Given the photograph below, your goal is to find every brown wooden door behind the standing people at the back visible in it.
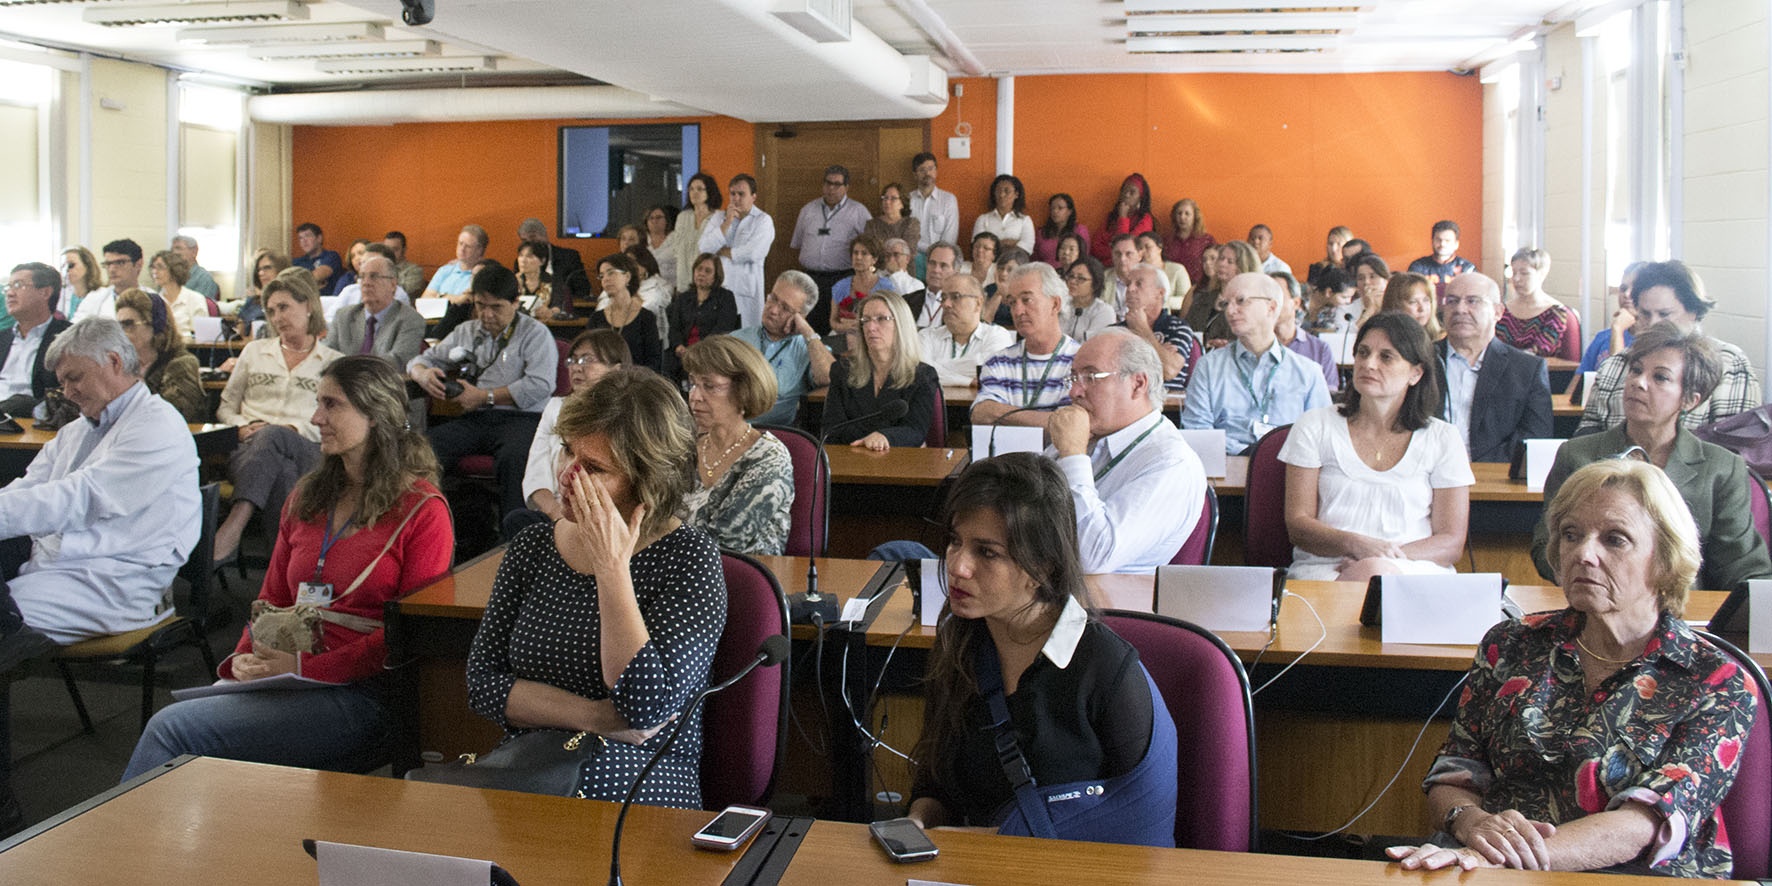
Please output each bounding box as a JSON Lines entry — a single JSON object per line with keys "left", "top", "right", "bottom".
{"left": 757, "top": 120, "right": 929, "bottom": 289}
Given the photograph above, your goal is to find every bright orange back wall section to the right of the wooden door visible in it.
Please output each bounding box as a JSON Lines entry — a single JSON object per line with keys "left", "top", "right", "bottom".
{"left": 930, "top": 73, "right": 1483, "bottom": 275}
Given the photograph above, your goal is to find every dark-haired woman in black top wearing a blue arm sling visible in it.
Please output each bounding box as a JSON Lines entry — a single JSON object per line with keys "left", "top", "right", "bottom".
{"left": 909, "top": 452, "right": 1177, "bottom": 845}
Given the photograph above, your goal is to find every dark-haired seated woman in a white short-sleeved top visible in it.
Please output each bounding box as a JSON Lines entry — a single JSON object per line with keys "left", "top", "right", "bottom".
{"left": 1279, "top": 312, "right": 1476, "bottom": 581}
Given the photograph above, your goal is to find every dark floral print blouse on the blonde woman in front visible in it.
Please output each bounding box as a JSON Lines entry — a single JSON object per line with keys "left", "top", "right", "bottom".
{"left": 1423, "top": 610, "right": 1754, "bottom": 877}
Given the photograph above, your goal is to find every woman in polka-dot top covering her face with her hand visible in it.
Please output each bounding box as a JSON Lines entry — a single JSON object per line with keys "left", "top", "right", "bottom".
{"left": 468, "top": 366, "right": 727, "bottom": 810}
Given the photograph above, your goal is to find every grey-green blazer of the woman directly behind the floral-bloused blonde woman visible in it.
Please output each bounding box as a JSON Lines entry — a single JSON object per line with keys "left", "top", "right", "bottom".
{"left": 1533, "top": 425, "right": 1772, "bottom": 590}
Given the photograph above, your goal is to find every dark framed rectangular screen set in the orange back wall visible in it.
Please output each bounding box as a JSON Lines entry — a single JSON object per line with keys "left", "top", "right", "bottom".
{"left": 556, "top": 122, "right": 702, "bottom": 237}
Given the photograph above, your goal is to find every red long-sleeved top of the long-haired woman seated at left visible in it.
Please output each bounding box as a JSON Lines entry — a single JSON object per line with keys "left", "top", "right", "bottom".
{"left": 220, "top": 480, "right": 455, "bottom": 684}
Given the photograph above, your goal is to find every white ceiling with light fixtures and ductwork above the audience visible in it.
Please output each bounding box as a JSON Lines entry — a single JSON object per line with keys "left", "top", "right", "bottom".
{"left": 0, "top": 0, "right": 1604, "bottom": 120}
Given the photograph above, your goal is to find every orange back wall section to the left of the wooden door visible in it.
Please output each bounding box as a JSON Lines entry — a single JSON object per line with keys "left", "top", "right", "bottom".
{"left": 282, "top": 117, "right": 757, "bottom": 269}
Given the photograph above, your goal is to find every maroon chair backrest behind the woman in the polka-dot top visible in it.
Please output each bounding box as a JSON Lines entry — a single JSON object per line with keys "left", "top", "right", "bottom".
{"left": 702, "top": 553, "right": 792, "bottom": 810}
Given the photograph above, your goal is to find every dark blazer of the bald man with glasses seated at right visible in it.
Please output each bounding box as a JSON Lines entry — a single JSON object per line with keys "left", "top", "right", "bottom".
{"left": 1434, "top": 338, "right": 1551, "bottom": 461}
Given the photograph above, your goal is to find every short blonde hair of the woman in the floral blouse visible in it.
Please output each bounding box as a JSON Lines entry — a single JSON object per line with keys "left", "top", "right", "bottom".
{"left": 1545, "top": 459, "right": 1701, "bottom": 617}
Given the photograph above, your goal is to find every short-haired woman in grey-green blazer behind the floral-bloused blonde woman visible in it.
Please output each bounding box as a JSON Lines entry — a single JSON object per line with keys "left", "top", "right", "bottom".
{"left": 1533, "top": 323, "right": 1772, "bottom": 590}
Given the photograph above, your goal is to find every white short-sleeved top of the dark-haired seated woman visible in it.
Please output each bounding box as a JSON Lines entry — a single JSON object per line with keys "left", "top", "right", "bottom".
{"left": 1279, "top": 406, "right": 1476, "bottom": 581}
